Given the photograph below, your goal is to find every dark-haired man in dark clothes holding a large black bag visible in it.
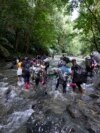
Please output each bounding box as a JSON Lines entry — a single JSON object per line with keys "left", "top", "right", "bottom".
{"left": 71, "top": 59, "right": 87, "bottom": 93}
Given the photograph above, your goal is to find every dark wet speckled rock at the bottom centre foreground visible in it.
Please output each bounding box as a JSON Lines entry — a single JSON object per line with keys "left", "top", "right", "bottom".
{"left": 27, "top": 112, "right": 88, "bottom": 133}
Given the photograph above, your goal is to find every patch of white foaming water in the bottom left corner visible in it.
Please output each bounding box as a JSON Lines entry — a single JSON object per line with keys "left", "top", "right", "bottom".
{"left": 1, "top": 109, "right": 33, "bottom": 133}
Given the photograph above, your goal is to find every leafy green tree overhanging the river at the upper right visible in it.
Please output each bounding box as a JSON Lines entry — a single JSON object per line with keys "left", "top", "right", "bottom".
{"left": 69, "top": 0, "right": 100, "bottom": 52}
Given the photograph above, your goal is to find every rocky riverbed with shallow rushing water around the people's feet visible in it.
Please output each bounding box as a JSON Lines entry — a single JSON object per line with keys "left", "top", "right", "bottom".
{"left": 0, "top": 57, "right": 100, "bottom": 133}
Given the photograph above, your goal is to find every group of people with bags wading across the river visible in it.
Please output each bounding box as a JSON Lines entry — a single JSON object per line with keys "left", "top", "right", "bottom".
{"left": 16, "top": 55, "right": 98, "bottom": 94}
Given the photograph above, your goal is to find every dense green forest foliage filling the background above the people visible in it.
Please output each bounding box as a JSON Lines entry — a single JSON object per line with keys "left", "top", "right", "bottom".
{"left": 0, "top": 0, "right": 100, "bottom": 57}
